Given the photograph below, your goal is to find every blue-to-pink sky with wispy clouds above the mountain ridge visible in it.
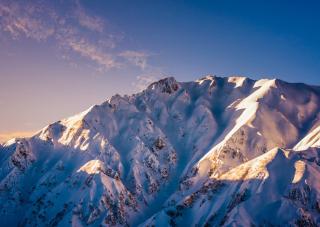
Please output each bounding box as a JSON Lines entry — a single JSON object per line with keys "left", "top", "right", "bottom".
{"left": 0, "top": 0, "right": 320, "bottom": 141}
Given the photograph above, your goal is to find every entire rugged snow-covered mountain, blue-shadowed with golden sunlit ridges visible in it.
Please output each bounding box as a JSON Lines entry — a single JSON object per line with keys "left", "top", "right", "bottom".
{"left": 0, "top": 76, "right": 320, "bottom": 226}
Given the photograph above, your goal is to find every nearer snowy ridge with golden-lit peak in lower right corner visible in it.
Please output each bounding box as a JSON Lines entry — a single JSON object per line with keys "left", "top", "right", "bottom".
{"left": 144, "top": 148, "right": 320, "bottom": 226}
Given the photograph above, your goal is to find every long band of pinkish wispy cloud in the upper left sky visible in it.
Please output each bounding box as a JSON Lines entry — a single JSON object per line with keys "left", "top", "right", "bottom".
{"left": 0, "top": 0, "right": 149, "bottom": 71}
